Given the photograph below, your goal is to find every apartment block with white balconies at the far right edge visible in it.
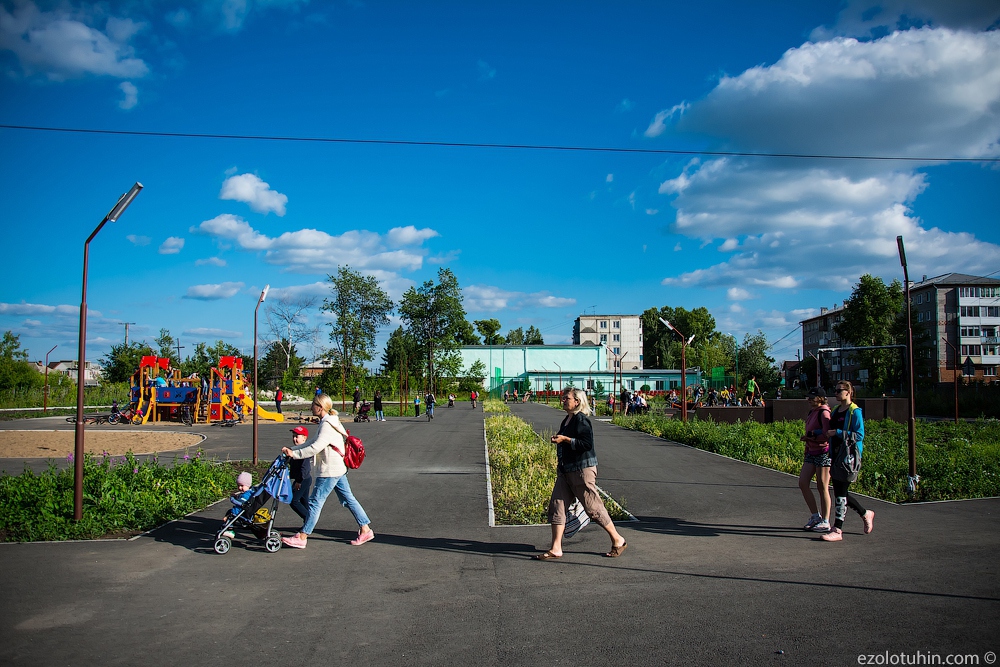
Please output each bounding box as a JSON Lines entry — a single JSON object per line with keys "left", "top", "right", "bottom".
{"left": 910, "top": 273, "right": 1000, "bottom": 382}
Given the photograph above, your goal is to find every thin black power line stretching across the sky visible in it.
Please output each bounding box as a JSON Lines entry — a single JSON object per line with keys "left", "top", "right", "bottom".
{"left": 0, "top": 124, "right": 1000, "bottom": 164}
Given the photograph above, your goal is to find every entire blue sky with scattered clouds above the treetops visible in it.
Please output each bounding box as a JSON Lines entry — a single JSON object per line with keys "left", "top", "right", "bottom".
{"left": 0, "top": 0, "right": 1000, "bottom": 370}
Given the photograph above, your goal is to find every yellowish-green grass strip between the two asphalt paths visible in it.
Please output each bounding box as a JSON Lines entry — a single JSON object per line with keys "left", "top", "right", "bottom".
{"left": 483, "top": 410, "right": 630, "bottom": 525}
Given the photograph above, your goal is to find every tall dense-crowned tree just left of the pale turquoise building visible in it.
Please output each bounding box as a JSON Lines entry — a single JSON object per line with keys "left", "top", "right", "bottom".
{"left": 399, "top": 268, "right": 468, "bottom": 391}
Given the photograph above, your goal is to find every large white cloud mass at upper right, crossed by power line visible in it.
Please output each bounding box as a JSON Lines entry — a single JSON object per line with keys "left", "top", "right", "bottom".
{"left": 659, "top": 29, "right": 1000, "bottom": 292}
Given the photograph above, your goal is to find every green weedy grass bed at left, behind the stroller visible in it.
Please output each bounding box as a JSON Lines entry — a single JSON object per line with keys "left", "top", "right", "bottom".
{"left": 0, "top": 451, "right": 270, "bottom": 542}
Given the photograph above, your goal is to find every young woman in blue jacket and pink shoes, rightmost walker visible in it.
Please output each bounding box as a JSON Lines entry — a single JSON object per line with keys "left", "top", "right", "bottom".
{"left": 823, "top": 380, "right": 875, "bottom": 542}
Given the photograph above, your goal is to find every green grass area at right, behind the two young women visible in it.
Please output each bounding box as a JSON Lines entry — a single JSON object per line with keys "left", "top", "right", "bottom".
{"left": 614, "top": 416, "right": 1000, "bottom": 502}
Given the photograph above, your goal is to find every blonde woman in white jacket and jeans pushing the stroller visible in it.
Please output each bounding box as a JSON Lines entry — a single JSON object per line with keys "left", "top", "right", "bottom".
{"left": 281, "top": 394, "right": 375, "bottom": 549}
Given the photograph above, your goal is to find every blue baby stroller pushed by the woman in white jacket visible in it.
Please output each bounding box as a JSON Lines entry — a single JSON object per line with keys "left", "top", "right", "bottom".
{"left": 215, "top": 454, "right": 292, "bottom": 554}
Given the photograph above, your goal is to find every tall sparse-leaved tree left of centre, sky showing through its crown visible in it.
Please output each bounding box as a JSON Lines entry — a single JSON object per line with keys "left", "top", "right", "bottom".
{"left": 322, "top": 266, "right": 394, "bottom": 373}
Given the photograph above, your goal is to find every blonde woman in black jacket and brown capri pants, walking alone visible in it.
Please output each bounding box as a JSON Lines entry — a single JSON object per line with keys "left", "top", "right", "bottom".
{"left": 534, "top": 388, "right": 628, "bottom": 560}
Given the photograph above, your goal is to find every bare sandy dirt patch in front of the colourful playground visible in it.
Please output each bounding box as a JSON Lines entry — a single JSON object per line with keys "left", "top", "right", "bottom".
{"left": 0, "top": 431, "right": 203, "bottom": 459}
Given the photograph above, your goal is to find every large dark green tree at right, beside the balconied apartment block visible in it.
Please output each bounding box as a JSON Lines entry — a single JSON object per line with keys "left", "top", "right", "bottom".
{"left": 834, "top": 273, "right": 905, "bottom": 389}
